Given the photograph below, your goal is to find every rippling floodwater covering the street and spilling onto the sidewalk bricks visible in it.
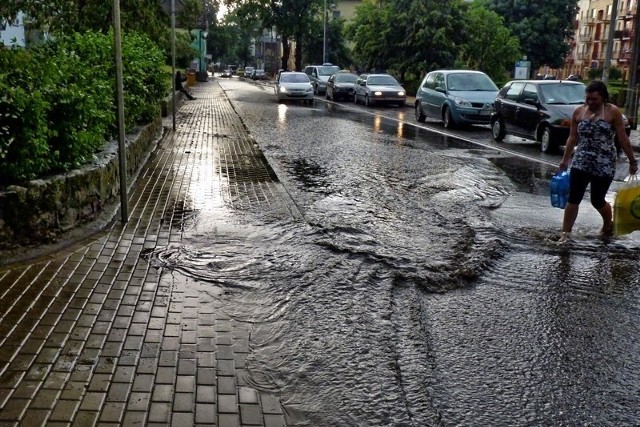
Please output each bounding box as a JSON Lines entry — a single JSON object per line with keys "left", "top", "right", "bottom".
{"left": 151, "top": 82, "right": 640, "bottom": 427}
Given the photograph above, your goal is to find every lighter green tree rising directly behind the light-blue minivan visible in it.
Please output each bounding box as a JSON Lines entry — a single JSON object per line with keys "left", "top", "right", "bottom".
{"left": 457, "top": 2, "right": 521, "bottom": 81}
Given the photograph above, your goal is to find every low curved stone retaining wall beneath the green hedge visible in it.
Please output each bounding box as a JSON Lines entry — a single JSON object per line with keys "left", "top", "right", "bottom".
{"left": 0, "top": 117, "right": 165, "bottom": 250}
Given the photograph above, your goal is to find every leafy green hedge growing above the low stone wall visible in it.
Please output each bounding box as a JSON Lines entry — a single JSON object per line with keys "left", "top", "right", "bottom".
{"left": 0, "top": 32, "right": 170, "bottom": 182}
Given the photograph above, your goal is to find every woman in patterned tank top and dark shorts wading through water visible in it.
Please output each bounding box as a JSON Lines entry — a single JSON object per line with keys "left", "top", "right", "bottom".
{"left": 560, "top": 80, "right": 638, "bottom": 242}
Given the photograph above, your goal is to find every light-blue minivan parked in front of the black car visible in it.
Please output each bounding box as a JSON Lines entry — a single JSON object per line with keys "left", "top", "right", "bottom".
{"left": 414, "top": 70, "right": 498, "bottom": 129}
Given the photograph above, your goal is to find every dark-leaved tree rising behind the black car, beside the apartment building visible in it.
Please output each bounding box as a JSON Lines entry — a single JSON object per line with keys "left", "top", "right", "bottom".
{"left": 477, "top": 0, "right": 578, "bottom": 70}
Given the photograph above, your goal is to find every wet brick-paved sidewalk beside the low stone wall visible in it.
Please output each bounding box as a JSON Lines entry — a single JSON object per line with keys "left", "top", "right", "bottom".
{"left": 0, "top": 81, "right": 287, "bottom": 427}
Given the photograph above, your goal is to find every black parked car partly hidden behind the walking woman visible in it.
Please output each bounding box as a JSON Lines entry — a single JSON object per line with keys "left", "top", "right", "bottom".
{"left": 491, "top": 80, "right": 631, "bottom": 153}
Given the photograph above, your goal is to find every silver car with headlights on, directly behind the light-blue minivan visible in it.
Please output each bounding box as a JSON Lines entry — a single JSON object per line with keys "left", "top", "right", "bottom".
{"left": 353, "top": 74, "right": 407, "bottom": 107}
